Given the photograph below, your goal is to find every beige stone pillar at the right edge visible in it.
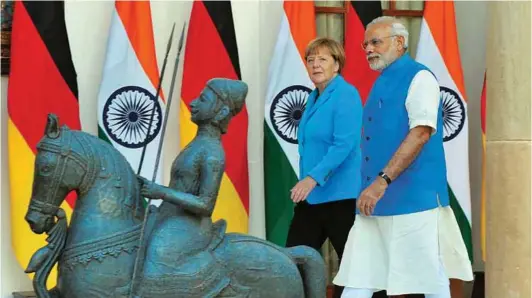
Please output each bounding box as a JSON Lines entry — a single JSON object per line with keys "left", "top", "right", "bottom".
{"left": 486, "top": 1, "right": 532, "bottom": 298}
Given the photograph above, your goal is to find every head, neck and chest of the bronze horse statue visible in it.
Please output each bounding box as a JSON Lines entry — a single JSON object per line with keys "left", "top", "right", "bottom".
{"left": 25, "top": 114, "right": 150, "bottom": 297}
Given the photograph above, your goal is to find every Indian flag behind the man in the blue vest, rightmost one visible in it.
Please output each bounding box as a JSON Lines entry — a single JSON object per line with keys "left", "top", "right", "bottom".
{"left": 416, "top": 1, "right": 473, "bottom": 260}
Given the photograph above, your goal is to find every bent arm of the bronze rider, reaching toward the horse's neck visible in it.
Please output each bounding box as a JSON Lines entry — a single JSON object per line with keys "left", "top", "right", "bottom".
{"left": 138, "top": 157, "right": 224, "bottom": 216}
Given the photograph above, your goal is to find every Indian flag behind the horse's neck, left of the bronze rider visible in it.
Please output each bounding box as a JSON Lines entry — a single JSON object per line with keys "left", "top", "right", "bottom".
{"left": 98, "top": 1, "right": 165, "bottom": 191}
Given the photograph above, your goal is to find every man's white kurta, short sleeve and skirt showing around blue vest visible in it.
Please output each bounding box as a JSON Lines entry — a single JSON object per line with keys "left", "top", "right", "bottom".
{"left": 333, "top": 70, "right": 473, "bottom": 295}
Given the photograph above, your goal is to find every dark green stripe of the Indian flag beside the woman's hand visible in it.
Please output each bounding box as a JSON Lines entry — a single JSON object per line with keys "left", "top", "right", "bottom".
{"left": 264, "top": 122, "right": 297, "bottom": 246}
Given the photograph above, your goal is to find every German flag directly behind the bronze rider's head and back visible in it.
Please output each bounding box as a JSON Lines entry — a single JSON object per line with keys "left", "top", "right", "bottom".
{"left": 179, "top": 1, "right": 249, "bottom": 233}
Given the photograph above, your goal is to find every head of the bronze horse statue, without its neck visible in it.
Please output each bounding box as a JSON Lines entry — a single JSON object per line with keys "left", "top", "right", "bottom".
{"left": 25, "top": 114, "right": 94, "bottom": 234}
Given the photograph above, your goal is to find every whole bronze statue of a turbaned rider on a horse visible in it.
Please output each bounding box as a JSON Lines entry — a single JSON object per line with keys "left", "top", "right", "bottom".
{"left": 22, "top": 79, "right": 326, "bottom": 298}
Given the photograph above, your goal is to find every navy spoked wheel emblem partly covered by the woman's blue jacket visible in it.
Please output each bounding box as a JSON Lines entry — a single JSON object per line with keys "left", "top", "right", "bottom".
{"left": 270, "top": 85, "right": 312, "bottom": 144}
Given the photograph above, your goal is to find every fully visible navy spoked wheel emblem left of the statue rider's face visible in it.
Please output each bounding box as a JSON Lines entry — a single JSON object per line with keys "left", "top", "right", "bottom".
{"left": 102, "top": 86, "right": 162, "bottom": 148}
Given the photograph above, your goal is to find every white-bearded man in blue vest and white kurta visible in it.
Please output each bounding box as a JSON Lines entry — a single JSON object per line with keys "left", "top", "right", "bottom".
{"left": 334, "top": 17, "right": 473, "bottom": 298}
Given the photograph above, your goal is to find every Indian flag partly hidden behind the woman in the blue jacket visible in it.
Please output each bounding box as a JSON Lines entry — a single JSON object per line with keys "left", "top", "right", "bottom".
{"left": 264, "top": 1, "right": 316, "bottom": 246}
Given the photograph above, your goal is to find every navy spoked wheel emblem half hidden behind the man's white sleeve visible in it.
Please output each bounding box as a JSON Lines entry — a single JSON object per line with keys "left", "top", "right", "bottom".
{"left": 440, "top": 87, "right": 466, "bottom": 142}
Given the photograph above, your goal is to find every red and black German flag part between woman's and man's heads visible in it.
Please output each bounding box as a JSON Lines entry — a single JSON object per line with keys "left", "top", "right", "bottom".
{"left": 342, "top": 1, "right": 382, "bottom": 103}
